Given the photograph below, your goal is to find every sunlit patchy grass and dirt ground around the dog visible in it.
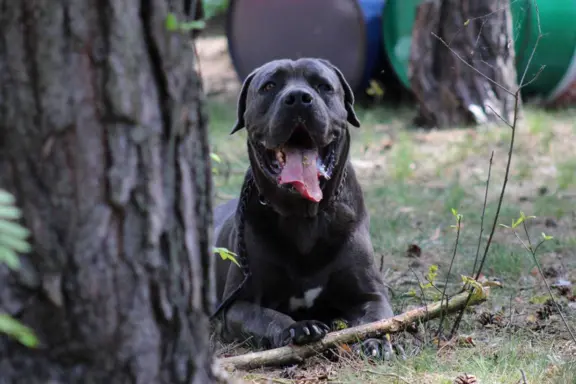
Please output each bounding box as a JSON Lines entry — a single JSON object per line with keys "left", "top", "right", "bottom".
{"left": 197, "top": 29, "right": 576, "bottom": 383}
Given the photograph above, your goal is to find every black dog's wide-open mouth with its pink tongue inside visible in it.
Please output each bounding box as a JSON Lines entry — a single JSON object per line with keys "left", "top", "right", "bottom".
{"left": 257, "top": 126, "right": 336, "bottom": 202}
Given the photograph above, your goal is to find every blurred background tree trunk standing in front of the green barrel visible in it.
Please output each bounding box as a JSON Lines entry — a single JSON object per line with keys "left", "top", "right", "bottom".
{"left": 409, "top": 0, "right": 517, "bottom": 128}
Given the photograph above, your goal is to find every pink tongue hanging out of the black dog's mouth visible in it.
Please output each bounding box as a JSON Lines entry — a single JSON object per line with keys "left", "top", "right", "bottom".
{"left": 279, "top": 148, "right": 322, "bottom": 203}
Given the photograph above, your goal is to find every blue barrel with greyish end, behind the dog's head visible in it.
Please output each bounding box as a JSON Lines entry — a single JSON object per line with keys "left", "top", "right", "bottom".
{"left": 226, "top": 0, "right": 385, "bottom": 92}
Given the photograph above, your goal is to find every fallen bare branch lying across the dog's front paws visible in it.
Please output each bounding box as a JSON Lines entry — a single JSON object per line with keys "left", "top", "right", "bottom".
{"left": 219, "top": 286, "right": 490, "bottom": 370}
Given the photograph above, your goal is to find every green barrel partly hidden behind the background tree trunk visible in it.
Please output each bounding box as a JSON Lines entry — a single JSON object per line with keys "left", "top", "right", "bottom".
{"left": 382, "top": 0, "right": 576, "bottom": 101}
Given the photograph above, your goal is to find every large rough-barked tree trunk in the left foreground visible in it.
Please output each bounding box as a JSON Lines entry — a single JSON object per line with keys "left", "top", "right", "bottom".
{"left": 0, "top": 0, "right": 215, "bottom": 384}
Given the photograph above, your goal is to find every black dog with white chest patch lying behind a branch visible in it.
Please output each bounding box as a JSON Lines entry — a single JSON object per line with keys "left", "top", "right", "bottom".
{"left": 214, "top": 58, "right": 393, "bottom": 356}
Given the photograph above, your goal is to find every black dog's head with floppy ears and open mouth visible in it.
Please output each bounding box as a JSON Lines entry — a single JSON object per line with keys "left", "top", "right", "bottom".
{"left": 232, "top": 58, "right": 360, "bottom": 207}
